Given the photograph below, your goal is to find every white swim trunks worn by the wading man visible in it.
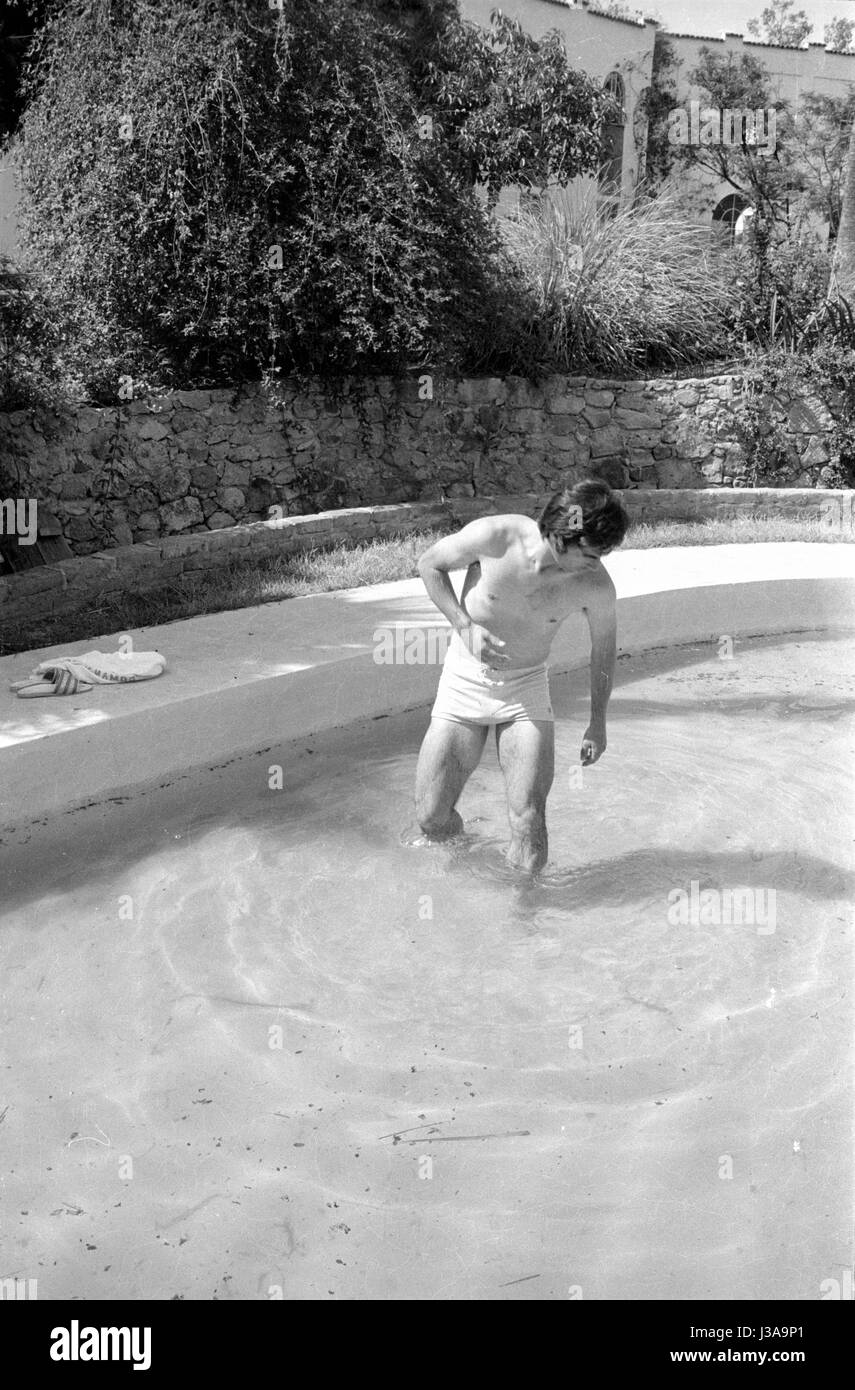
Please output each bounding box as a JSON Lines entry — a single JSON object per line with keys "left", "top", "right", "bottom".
{"left": 431, "top": 632, "right": 555, "bottom": 724}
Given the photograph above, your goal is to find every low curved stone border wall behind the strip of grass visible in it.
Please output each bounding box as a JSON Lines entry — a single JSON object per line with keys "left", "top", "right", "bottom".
{"left": 0, "top": 488, "right": 855, "bottom": 632}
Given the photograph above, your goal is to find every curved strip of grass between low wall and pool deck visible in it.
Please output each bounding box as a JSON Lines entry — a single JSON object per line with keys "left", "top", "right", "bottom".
{"left": 0, "top": 516, "right": 849, "bottom": 656}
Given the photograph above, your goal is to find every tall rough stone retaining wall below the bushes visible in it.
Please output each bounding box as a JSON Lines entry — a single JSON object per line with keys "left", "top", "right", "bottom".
{"left": 0, "top": 375, "right": 833, "bottom": 555}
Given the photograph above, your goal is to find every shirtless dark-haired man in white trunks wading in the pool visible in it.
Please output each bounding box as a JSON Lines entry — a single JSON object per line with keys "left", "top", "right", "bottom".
{"left": 416, "top": 480, "right": 628, "bottom": 872}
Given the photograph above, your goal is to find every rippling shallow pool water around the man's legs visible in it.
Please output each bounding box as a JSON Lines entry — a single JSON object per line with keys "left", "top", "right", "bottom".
{"left": 0, "top": 634, "right": 855, "bottom": 1300}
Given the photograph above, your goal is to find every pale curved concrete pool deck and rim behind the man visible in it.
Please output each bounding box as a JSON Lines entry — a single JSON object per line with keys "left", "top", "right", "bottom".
{"left": 0, "top": 542, "right": 855, "bottom": 828}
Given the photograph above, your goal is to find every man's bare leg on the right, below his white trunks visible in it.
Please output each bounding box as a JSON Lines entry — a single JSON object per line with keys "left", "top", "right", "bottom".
{"left": 496, "top": 719, "right": 555, "bottom": 873}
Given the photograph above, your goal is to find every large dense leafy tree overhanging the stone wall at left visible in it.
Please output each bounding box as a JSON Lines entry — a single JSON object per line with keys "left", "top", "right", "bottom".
{"left": 17, "top": 0, "right": 605, "bottom": 400}
